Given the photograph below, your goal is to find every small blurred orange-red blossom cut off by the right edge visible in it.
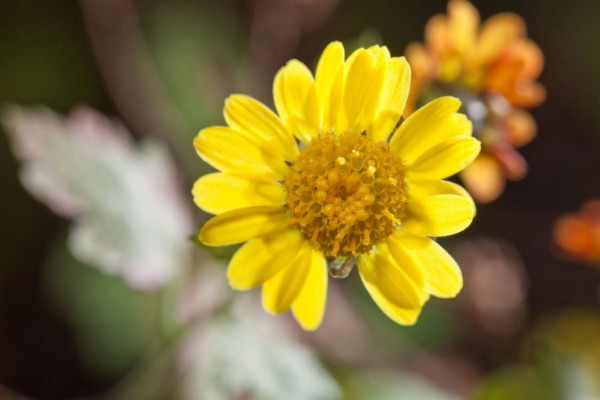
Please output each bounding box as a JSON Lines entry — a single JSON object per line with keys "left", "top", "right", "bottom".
{"left": 553, "top": 200, "right": 600, "bottom": 265}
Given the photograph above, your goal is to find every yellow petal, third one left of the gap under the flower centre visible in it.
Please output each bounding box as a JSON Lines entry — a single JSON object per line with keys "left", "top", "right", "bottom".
{"left": 227, "top": 229, "right": 304, "bottom": 290}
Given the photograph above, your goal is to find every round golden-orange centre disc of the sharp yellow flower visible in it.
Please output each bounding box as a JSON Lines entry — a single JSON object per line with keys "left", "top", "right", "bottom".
{"left": 284, "top": 133, "right": 406, "bottom": 257}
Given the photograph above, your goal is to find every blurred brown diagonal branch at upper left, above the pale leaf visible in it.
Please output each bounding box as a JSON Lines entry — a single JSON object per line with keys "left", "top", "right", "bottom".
{"left": 80, "top": 0, "right": 193, "bottom": 173}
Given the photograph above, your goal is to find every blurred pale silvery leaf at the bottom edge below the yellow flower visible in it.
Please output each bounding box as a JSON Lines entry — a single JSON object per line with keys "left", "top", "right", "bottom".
{"left": 183, "top": 318, "right": 341, "bottom": 400}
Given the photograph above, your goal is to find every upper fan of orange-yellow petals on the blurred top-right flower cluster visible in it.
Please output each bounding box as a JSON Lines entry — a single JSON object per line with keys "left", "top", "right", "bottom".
{"left": 406, "top": 0, "right": 546, "bottom": 112}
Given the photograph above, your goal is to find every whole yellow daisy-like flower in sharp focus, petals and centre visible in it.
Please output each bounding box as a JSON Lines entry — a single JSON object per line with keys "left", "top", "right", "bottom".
{"left": 193, "top": 42, "right": 480, "bottom": 329}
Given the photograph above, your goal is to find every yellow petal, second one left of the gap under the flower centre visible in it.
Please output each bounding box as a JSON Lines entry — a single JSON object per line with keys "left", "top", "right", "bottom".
{"left": 262, "top": 241, "right": 312, "bottom": 314}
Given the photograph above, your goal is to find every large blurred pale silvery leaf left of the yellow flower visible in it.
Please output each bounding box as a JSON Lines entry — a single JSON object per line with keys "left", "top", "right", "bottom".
{"left": 3, "top": 107, "right": 193, "bottom": 289}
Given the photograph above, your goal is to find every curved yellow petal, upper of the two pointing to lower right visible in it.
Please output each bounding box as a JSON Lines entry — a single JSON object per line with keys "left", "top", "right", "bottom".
{"left": 387, "top": 230, "right": 463, "bottom": 298}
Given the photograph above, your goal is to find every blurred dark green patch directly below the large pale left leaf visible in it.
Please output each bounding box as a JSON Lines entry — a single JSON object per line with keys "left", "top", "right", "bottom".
{"left": 46, "top": 236, "right": 160, "bottom": 379}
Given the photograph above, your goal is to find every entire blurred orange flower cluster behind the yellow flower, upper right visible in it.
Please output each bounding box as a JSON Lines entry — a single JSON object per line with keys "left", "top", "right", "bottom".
{"left": 406, "top": 0, "right": 546, "bottom": 203}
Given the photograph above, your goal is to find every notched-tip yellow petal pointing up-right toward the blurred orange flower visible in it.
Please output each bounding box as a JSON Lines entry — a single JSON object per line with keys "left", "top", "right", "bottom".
{"left": 390, "top": 96, "right": 472, "bottom": 164}
